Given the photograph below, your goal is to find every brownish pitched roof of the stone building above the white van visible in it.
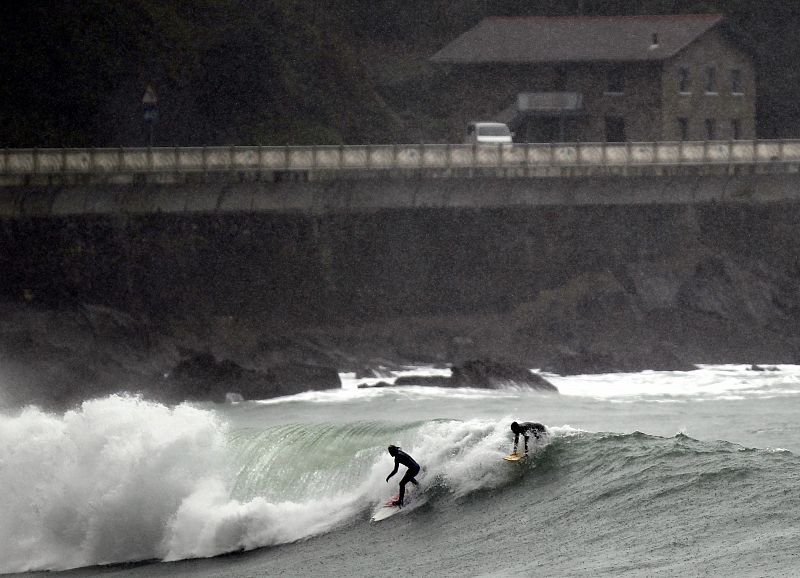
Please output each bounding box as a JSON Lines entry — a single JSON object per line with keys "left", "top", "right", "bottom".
{"left": 431, "top": 14, "right": 722, "bottom": 64}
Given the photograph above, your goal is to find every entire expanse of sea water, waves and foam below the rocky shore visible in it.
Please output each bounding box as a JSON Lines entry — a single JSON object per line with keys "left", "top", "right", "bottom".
{"left": 0, "top": 365, "right": 800, "bottom": 577}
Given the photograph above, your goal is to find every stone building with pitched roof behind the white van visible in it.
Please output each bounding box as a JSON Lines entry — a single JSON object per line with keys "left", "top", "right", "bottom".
{"left": 431, "top": 14, "right": 756, "bottom": 142}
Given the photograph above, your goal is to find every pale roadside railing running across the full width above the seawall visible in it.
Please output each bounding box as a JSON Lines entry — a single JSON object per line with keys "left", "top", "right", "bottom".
{"left": 0, "top": 140, "right": 800, "bottom": 176}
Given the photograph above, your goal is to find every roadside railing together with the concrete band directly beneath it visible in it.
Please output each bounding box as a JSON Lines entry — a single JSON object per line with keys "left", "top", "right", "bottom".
{"left": 0, "top": 140, "right": 800, "bottom": 218}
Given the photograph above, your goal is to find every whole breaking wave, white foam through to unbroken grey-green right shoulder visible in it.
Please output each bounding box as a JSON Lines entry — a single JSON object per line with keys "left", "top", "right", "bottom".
{"left": 0, "top": 396, "right": 800, "bottom": 572}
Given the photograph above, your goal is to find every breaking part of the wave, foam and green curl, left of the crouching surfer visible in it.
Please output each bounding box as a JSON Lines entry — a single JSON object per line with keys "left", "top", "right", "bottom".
{"left": 0, "top": 396, "right": 556, "bottom": 572}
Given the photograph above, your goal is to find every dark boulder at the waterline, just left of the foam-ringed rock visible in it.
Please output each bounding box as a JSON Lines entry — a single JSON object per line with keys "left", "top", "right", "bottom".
{"left": 167, "top": 353, "right": 342, "bottom": 402}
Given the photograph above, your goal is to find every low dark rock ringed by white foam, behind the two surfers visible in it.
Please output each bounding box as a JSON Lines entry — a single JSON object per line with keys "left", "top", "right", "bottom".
{"left": 395, "top": 359, "right": 558, "bottom": 393}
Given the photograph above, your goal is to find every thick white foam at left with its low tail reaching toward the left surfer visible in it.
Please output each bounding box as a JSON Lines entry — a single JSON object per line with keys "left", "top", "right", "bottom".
{"left": 0, "top": 396, "right": 368, "bottom": 572}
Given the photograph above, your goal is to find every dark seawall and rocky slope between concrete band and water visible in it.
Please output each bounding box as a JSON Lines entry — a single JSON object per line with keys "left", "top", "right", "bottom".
{"left": 0, "top": 204, "right": 800, "bottom": 404}
